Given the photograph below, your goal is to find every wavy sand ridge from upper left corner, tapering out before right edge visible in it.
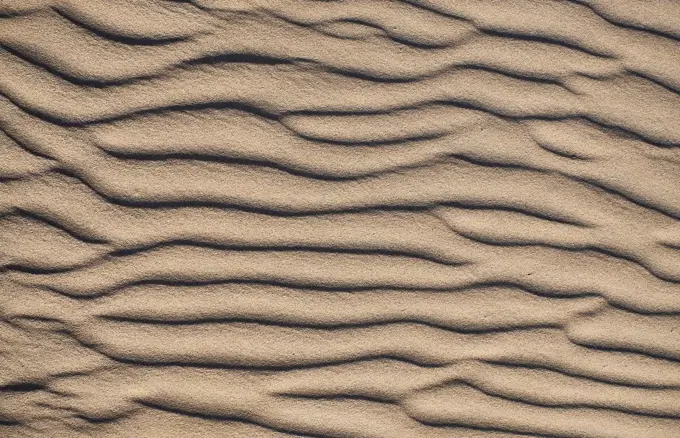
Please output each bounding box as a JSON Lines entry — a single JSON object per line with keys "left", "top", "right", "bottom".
{"left": 0, "top": 8, "right": 624, "bottom": 85}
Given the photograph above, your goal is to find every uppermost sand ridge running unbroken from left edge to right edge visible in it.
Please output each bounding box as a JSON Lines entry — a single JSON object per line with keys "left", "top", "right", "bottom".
{"left": 0, "top": 45, "right": 680, "bottom": 144}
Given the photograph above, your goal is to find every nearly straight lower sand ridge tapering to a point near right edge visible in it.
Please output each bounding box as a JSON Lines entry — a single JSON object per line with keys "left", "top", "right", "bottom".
{"left": 3, "top": 283, "right": 603, "bottom": 333}
